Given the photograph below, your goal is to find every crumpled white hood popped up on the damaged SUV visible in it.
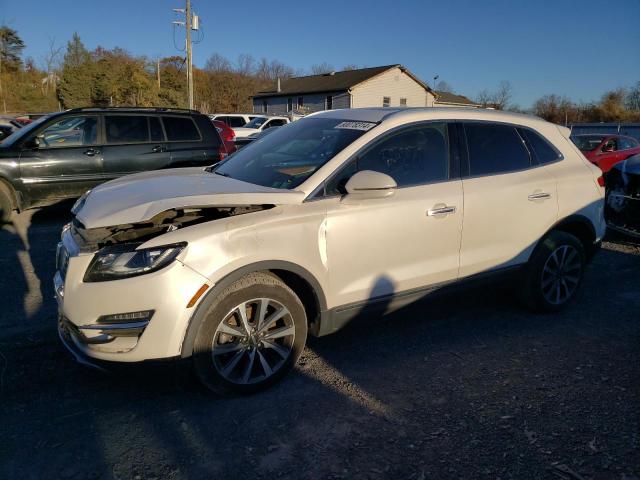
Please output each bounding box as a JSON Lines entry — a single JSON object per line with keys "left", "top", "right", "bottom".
{"left": 76, "top": 167, "right": 305, "bottom": 228}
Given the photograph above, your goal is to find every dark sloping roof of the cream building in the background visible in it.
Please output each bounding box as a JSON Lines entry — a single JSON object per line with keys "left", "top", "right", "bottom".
{"left": 254, "top": 64, "right": 432, "bottom": 98}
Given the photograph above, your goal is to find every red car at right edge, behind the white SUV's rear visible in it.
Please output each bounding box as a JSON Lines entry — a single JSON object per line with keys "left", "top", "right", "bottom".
{"left": 571, "top": 134, "right": 640, "bottom": 173}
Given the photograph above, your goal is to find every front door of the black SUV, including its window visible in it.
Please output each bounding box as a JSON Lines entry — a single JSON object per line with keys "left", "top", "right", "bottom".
{"left": 20, "top": 114, "right": 105, "bottom": 203}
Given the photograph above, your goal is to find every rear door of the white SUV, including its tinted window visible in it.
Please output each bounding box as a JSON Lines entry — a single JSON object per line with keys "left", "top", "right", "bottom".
{"left": 460, "top": 122, "right": 558, "bottom": 278}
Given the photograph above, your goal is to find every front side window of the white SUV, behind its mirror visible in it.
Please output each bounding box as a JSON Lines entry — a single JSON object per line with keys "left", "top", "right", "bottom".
{"left": 325, "top": 123, "right": 449, "bottom": 196}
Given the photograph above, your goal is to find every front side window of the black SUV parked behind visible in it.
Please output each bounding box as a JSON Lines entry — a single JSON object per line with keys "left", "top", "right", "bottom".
{"left": 37, "top": 115, "right": 98, "bottom": 148}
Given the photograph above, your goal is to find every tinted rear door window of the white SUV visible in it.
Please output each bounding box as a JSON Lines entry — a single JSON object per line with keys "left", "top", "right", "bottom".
{"left": 464, "top": 123, "right": 531, "bottom": 175}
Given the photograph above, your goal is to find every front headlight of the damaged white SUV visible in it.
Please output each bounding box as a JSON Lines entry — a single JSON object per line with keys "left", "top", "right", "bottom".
{"left": 84, "top": 243, "right": 187, "bottom": 282}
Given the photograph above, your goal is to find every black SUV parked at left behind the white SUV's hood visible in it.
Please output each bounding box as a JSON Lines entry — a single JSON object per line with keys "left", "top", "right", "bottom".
{"left": 0, "top": 108, "right": 227, "bottom": 221}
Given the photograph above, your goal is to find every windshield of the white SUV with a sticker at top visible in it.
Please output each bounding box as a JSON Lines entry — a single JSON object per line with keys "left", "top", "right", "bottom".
{"left": 213, "top": 118, "right": 376, "bottom": 189}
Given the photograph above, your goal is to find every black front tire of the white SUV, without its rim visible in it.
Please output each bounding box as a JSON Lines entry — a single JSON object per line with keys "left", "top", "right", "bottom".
{"left": 192, "top": 280, "right": 307, "bottom": 395}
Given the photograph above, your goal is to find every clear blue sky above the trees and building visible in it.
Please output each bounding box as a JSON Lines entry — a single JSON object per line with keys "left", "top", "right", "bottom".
{"left": 0, "top": 0, "right": 640, "bottom": 107}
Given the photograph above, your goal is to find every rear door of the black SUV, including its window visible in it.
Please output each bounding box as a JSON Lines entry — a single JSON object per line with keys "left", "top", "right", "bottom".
{"left": 102, "top": 114, "right": 171, "bottom": 178}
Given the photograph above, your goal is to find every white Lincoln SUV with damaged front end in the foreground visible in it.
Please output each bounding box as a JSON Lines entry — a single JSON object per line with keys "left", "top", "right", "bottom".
{"left": 54, "top": 108, "right": 605, "bottom": 392}
